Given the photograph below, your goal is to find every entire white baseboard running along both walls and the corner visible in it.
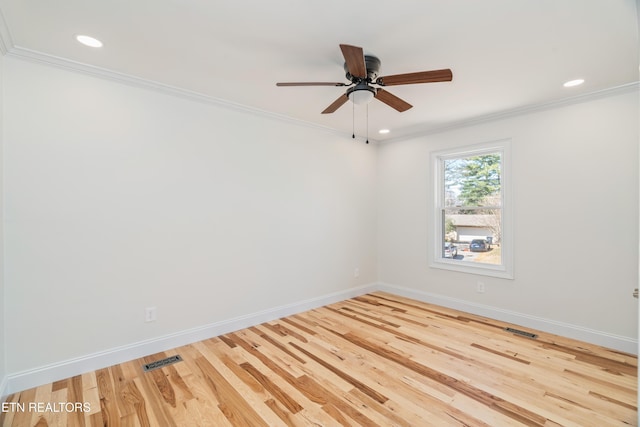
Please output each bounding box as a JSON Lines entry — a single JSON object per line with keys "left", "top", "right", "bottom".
{"left": 0, "top": 283, "right": 638, "bottom": 401}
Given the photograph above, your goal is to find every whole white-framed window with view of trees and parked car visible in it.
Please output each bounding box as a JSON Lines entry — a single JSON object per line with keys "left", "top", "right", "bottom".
{"left": 430, "top": 141, "right": 513, "bottom": 278}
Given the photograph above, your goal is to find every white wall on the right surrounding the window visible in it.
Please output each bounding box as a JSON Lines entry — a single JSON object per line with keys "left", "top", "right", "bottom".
{"left": 378, "top": 86, "right": 639, "bottom": 340}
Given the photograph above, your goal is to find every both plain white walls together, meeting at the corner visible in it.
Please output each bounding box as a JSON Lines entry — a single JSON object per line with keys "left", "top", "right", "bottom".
{"left": 0, "top": 52, "right": 639, "bottom": 388}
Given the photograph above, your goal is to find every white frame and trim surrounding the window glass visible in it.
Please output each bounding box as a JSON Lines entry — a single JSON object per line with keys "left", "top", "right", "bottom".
{"left": 428, "top": 139, "right": 513, "bottom": 279}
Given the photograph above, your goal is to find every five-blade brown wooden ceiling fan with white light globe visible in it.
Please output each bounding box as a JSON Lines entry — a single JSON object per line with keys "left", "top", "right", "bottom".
{"left": 276, "top": 44, "right": 453, "bottom": 114}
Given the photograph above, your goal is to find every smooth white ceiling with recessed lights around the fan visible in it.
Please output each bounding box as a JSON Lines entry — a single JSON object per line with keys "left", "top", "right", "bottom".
{"left": 0, "top": 0, "right": 639, "bottom": 140}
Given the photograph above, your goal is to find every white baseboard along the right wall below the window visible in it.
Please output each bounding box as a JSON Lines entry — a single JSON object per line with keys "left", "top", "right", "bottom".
{"left": 378, "top": 283, "right": 638, "bottom": 355}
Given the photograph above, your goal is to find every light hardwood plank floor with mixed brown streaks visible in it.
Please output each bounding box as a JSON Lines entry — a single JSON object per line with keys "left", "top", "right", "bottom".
{"left": 0, "top": 292, "right": 637, "bottom": 427}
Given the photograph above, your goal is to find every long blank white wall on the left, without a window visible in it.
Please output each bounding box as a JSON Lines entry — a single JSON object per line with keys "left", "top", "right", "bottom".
{"left": 4, "top": 57, "right": 377, "bottom": 373}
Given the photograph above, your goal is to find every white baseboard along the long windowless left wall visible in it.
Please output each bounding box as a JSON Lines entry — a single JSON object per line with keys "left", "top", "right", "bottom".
{"left": 0, "top": 283, "right": 377, "bottom": 398}
